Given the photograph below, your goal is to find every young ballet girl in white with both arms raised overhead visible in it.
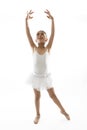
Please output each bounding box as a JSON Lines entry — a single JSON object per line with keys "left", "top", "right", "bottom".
{"left": 25, "top": 10, "right": 70, "bottom": 124}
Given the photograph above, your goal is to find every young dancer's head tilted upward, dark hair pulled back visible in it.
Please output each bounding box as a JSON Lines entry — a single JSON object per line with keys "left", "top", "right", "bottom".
{"left": 36, "top": 30, "right": 48, "bottom": 45}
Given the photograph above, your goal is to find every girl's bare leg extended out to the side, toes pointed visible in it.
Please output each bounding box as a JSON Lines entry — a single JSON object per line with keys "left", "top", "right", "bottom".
{"left": 47, "top": 88, "right": 70, "bottom": 120}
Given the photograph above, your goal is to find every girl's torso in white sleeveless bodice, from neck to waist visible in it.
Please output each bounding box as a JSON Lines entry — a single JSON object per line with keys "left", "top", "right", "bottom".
{"left": 34, "top": 48, "right": 48, "bottom": 75}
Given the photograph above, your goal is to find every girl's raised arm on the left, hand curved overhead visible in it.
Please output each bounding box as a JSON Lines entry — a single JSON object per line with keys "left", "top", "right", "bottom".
{"left": 25, "top": 10, "right": 36, "bottom": 49}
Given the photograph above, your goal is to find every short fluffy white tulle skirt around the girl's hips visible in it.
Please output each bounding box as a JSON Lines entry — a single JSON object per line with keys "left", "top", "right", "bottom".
{"left": 29, "top": 73, "right": 52, "bottom": 91}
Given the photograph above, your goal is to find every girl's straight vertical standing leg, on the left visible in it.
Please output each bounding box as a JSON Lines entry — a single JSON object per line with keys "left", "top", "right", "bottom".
{"left": 34, "top": 89, "right": 40, "bottom": 124}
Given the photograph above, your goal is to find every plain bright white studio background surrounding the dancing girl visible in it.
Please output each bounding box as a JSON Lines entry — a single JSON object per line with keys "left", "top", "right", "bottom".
{"left": 0, "top": 0, "right": 87, "bottom": 130}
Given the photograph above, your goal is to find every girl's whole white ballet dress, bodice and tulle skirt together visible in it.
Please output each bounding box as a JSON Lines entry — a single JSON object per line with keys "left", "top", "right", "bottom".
{"left": 30, "top": 51, "right": 52, "bottom": 91}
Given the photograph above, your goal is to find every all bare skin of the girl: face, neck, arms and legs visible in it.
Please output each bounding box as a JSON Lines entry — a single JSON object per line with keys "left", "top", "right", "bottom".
{"left": 25, "top": 10, "right": 70, "bottom": 124}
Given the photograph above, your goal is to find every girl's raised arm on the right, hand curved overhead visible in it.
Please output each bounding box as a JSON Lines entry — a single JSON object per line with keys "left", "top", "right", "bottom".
{"left": 45, "top": 10, "right": 55, "bottom": 50}
